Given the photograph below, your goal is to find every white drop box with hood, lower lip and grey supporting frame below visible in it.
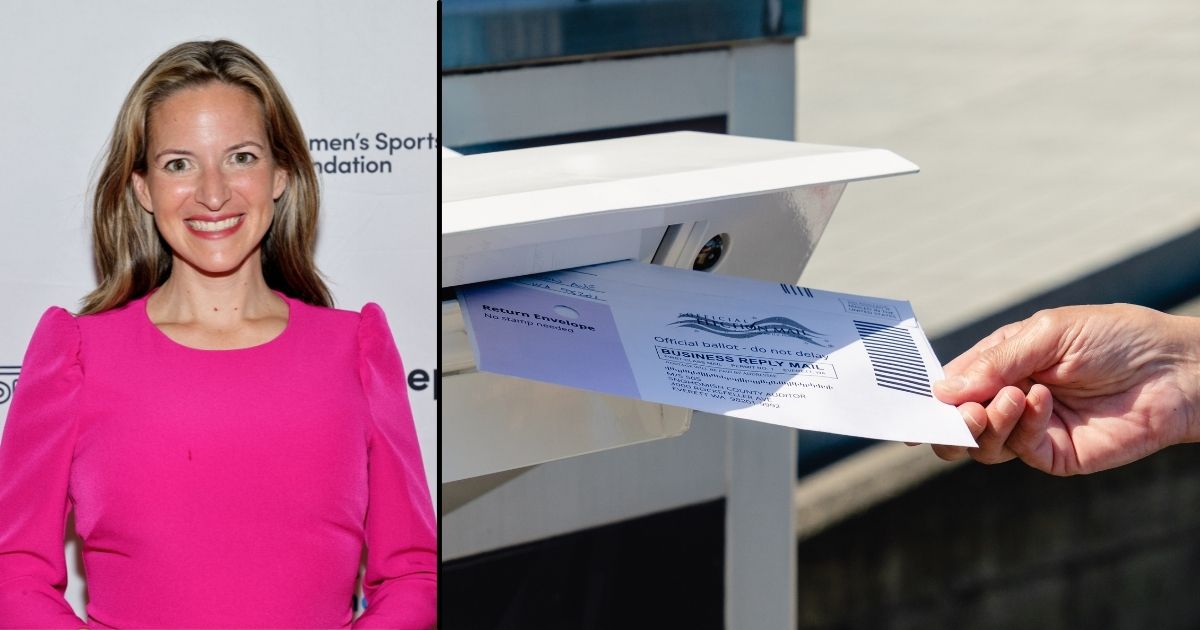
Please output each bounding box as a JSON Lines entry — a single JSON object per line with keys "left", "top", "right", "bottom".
{"left": 440, "top": 132, "right": 917, "bottom": 628}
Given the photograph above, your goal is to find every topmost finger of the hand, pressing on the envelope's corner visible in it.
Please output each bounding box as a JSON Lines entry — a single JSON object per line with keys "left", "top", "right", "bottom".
{"left": 935, "top": 312, "right": 1070, "bottom": 404}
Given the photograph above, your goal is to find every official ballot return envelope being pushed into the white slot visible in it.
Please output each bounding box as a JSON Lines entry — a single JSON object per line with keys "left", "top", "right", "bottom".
{"left": 458, "top": 262, "right": 976, "bottom": 446}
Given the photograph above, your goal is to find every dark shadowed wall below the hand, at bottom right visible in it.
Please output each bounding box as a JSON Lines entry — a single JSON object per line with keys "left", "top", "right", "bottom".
{"left": 797, "top": 445, "right": 1200, "bottom": 630}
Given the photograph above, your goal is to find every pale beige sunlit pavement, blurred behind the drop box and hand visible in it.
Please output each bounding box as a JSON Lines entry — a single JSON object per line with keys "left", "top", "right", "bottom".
{"left": 797, "top": 0, "right": 1200, "bottom": 338}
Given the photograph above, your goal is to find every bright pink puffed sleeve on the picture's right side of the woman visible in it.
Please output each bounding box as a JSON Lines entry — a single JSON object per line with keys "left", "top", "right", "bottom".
{"left": 354, "top": 304, "right": 438, "bottom": 630}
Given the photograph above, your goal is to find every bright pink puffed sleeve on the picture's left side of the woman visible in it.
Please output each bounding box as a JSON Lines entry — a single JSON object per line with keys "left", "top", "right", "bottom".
{"left": 0, "top": 308, "right": 86, "bottom": 628}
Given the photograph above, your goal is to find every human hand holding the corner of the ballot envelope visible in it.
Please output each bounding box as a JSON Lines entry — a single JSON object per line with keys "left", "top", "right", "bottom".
{"left": 934, "top": 305, "right": 1200, "bottom": 475}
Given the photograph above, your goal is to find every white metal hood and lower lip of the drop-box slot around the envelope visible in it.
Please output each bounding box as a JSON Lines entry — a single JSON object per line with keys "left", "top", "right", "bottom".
{"left": 442, "top": 132, "right": 917, "bottom": 482}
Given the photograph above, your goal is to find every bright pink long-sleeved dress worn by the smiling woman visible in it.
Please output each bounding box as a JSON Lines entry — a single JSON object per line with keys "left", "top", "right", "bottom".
{"left": 0, "top": 298, "right": 437, "bottom": 629}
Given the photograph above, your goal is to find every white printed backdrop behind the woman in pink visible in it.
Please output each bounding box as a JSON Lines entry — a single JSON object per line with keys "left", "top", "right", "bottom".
{"left": 0, "top": 0, "right": 438, "bottom": 605}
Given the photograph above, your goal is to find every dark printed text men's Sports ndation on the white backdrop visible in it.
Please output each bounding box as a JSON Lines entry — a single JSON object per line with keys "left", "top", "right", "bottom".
{"left": 308, "top": 131, "right": 440, "bottom": 175}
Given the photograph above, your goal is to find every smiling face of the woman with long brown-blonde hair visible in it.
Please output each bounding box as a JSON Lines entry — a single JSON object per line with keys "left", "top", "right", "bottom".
{"left": 133, "top": 82, "right": 288, "bottom": 275}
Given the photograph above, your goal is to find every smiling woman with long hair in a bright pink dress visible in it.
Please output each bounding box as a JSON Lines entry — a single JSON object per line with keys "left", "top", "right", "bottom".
{"left": 0, "top": 41, "right": 437, "bottom": 628}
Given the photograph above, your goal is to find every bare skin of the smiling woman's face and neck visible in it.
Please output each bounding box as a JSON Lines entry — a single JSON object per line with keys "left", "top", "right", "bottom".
{"left": 133, "top": 83, "right": 292, "bottom": 348}
